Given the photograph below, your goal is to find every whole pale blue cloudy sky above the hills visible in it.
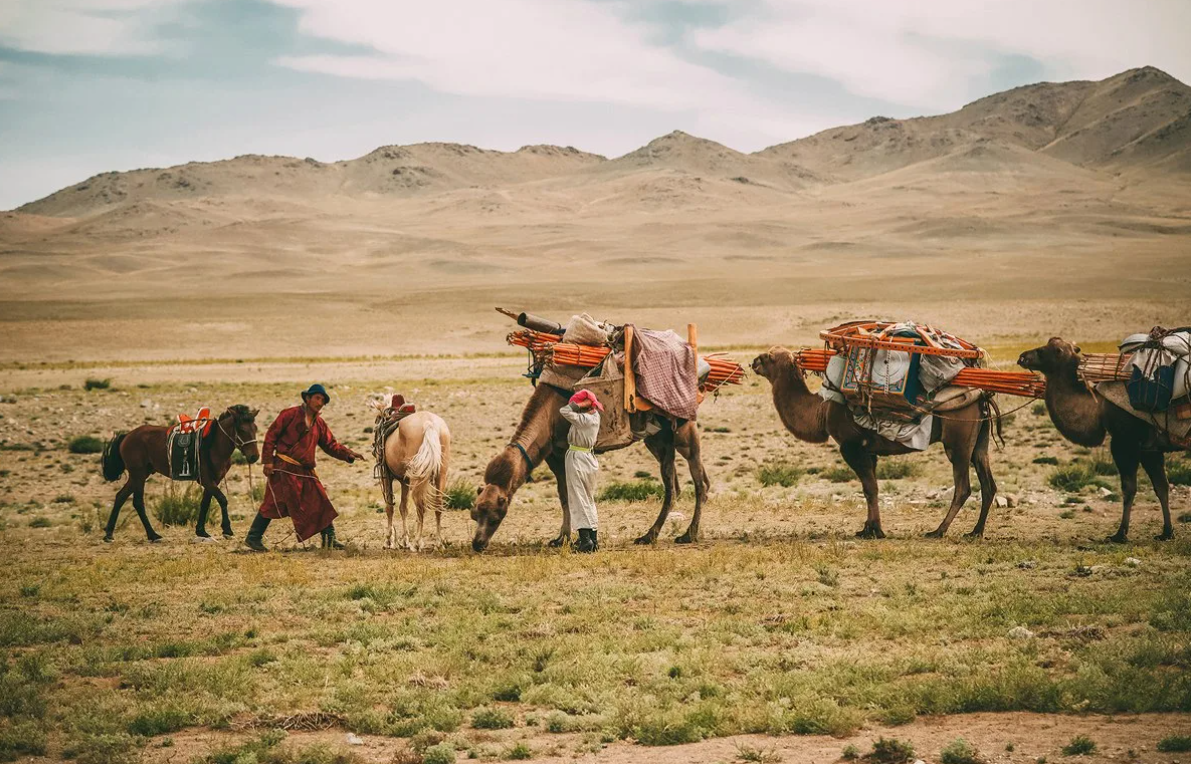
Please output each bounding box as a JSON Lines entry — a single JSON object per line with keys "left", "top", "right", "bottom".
{"left": 0, "top": 0, "right": 1191, "bottom": 210}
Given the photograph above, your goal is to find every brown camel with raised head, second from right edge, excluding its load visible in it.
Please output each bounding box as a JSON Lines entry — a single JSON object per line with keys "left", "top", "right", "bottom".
{"left": 753, "top": 347, "right": 1000, "bottom": 539}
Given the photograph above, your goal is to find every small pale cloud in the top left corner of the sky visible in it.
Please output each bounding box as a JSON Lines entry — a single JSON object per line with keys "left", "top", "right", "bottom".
{"left": 0, "top": 0, "right": 185, "bottom": 56}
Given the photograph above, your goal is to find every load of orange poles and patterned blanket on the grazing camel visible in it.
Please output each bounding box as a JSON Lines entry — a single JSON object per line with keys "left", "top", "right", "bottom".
{"left": 497, "top": 308, "right": 744, "bottom": 451}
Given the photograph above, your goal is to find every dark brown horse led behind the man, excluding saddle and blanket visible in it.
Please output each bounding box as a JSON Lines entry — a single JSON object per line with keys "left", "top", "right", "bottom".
{"left": 102, "top": 404, "right": 261, "bottom": 541}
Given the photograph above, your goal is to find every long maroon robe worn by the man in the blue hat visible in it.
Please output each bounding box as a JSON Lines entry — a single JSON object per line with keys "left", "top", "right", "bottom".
{"left": 261, "top": 406, "right": 355, "bottom": 541}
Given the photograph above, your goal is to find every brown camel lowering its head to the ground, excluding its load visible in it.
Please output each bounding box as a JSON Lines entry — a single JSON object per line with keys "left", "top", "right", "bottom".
{"left": 472, "top": 384, "right": 711, "bottom": 552}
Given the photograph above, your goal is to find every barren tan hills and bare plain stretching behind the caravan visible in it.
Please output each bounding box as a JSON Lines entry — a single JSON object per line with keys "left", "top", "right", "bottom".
{"left": 0, "top": 68, "right": 1191, "bottom": 360}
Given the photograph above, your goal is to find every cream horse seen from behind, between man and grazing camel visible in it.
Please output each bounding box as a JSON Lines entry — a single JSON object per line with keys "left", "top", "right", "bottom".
{"left": 376, "top": 404, "right": 450, "bottom": 552}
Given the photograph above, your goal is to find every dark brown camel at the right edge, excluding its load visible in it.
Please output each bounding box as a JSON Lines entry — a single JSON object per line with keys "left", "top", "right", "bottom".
{"left": 1017, "top": 337, "right": 1185, "bottom": 544}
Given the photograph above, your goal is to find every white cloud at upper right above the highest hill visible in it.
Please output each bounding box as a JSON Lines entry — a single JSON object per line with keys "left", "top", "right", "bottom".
{"left": 688, "top": 0, "right": 1191, "bottom": 111}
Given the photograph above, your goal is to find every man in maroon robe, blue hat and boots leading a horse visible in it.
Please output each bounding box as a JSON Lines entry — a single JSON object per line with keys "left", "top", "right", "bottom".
{"left": 245, "top": 385, "right": 363, "bottom": 552}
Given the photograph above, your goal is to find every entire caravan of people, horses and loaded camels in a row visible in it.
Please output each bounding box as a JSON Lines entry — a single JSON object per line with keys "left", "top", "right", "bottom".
{"left": 102, "top": 308, "right": 1191, "bottom": 552}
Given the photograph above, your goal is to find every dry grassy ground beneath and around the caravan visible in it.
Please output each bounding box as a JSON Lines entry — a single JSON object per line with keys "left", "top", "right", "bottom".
{"left": 0, "top": 361, "right": 1191, "bottom": 760}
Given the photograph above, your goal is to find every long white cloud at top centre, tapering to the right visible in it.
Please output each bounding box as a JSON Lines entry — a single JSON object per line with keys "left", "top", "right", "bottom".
{"left": 273, "top": 0, "right": 767, "bottom": 110}
